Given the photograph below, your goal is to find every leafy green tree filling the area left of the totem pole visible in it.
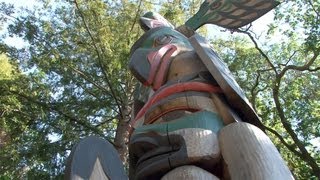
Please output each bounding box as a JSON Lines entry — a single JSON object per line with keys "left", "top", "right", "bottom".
{"left": 0, "top": 0, "right": 201, "bottom": 179}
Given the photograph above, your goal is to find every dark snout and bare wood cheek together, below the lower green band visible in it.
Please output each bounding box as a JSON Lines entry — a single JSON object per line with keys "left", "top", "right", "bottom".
{"left": 134, "top": 128, "right": 220, "bottom": 179}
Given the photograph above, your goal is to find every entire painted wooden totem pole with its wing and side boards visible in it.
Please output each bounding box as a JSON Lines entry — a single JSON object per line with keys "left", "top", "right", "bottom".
{"left": 67, "top": 0, "right": 293, "bottom": 180}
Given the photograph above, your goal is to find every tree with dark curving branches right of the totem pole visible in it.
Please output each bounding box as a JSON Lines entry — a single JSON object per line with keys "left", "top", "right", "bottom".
{"left": 209, "top": 1, "right": 320, "bottom": 179}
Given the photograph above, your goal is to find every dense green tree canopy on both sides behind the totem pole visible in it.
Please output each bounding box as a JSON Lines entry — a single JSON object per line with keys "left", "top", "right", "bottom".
{"left": 0, "top": 0, "right": 320, "bottom": 179}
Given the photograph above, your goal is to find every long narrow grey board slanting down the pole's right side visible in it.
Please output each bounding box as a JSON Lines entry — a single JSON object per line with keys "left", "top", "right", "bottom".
{"left": 189, "top": 34, "right": 264, "bottom": 130}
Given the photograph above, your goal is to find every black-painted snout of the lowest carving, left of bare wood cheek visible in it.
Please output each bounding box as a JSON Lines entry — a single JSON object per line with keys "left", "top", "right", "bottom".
{"left": 130, "top": 133, "right": 186, "bottom": 179}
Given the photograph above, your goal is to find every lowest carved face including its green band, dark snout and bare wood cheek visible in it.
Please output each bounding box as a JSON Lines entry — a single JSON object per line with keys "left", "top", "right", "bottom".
{"left": 129, "top": 111, "right": 223, "bottom": 179}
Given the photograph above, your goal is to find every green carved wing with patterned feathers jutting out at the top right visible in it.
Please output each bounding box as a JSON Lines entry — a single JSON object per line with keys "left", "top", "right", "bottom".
{"left": 185, "top": 0, "right": 279, "bottom": 30}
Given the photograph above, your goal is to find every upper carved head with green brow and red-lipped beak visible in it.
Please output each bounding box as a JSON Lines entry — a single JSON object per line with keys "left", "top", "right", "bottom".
{"left": 129, "top": 27, "right": 192, "bottom": 90}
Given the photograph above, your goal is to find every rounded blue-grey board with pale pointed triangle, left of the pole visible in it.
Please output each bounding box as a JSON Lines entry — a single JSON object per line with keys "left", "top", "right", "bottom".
{"left": 65, "top": 136, "right": 128, "bottom": 180}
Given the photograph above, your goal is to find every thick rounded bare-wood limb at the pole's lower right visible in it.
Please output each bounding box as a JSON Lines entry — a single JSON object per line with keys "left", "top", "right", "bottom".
{"left": 218, "top": 122, "right": 294, "bottom": 180}
